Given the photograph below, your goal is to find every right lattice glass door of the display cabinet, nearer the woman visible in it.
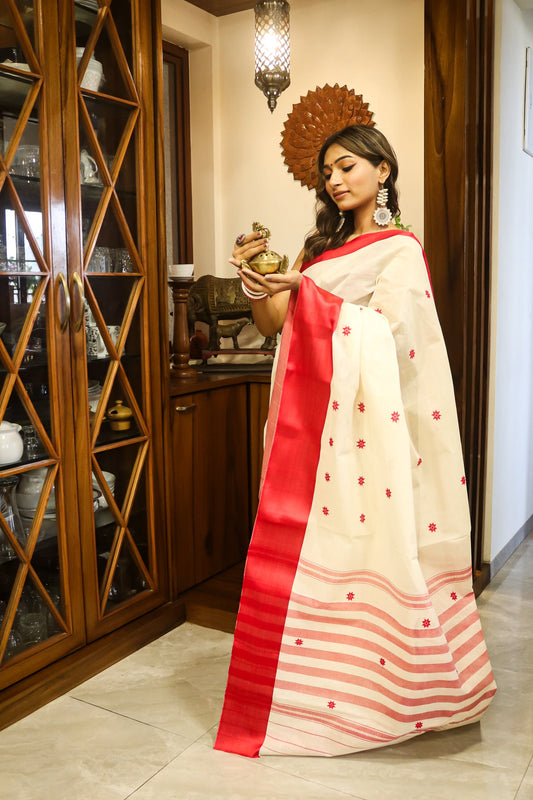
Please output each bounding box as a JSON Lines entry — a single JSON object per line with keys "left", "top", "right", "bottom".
{"left": 60, "top": 0, "right": 166, "bottom": 640}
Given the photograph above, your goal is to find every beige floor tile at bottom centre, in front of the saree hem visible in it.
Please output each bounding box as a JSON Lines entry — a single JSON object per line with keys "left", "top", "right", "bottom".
{"left": 125, "top": 744, "right": 364, "bottom": 800}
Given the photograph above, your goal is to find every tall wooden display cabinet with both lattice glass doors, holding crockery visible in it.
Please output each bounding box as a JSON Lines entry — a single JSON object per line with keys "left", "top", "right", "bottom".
{"left": 0, "top": 0, "right": 166, "bottom": 688}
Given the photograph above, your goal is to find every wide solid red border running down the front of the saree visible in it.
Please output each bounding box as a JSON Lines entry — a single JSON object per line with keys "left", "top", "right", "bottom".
{"left": 215, "top": 278, "right": 342, "bottom": 757}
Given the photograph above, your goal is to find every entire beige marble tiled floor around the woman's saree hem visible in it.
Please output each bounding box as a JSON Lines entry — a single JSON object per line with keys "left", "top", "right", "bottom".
{"left": 0, "top": 537, "right": 533, "bottom": 800}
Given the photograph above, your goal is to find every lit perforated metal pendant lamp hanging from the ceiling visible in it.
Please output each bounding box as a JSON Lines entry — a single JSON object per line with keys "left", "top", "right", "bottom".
{"left": 255, "top": 0, "right": 291, "bottom": 111}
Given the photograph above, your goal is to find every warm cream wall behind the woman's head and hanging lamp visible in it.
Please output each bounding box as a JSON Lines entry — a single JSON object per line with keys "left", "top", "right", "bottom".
{"left": 162, "top": 0, "right": 424, "bottom": 275}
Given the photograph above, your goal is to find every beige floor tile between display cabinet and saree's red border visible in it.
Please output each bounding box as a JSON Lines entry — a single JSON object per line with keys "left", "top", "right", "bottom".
{"left": 71, "top": 624, "right": 233, "bottom": 743}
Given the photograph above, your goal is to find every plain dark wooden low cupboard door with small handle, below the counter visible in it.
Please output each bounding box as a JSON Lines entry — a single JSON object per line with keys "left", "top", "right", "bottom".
{"left": 171, "top": 385, "right": 249, "bottom": 591}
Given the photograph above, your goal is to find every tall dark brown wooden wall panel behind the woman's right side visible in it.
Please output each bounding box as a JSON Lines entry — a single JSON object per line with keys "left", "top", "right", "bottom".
{"left": 424, "top": 0, "right": 494, "bottom": 575}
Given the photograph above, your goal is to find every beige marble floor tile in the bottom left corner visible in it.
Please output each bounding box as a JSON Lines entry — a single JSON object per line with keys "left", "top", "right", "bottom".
{"left": 0, "top": 697, "right": 188, "bottom": 800}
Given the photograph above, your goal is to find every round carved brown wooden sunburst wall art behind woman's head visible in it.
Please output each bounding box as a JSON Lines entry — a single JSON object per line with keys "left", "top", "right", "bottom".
{"left": 281, "top": 83, "right": 375, "bottom": 189}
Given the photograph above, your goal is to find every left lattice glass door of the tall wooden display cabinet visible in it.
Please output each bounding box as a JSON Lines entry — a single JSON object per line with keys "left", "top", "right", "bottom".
{"left": 0, "top": 0, "right": 85, "bottom": 688}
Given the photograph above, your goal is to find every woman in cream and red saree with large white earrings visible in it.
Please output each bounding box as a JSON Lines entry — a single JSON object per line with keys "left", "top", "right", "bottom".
{"left": 215, "top": 125, "right": 496, "bottom": 756}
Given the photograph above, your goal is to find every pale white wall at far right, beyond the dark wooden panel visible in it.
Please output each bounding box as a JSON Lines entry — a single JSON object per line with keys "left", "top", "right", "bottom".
{"left": 484, "top": 0, "right": 533, "bottom": 566}
